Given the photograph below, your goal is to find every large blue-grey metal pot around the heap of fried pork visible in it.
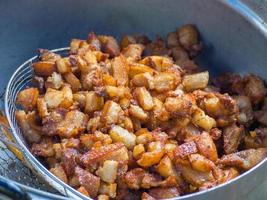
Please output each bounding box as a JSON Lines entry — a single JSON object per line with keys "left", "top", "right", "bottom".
{"left": 0, "top": 0, "right": 267, "bottom": 200}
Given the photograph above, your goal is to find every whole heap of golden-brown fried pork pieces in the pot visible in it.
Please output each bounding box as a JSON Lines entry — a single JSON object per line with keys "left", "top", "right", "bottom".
{"left": 16, "top": 25, "right": 267, "bottom": 200}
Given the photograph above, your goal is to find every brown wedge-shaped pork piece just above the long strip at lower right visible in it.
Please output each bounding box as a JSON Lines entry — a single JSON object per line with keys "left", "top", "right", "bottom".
{"left": 223, "top": 124, "right": 244, "bottom": 154}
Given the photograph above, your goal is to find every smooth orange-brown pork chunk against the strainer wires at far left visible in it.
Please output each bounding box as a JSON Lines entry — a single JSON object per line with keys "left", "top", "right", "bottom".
{"left": 16, "top": 88, "right": 39, "bottom": 111}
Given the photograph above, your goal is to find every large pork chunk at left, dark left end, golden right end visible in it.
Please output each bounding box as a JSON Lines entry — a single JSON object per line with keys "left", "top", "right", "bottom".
{"left": 43, "top": 109, "right": 88, "bottom": 138}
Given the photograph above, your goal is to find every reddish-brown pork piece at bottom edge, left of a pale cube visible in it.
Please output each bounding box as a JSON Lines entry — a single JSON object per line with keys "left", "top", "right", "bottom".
{"left": 75, "top": 166, "right": 100, "bottom": 198}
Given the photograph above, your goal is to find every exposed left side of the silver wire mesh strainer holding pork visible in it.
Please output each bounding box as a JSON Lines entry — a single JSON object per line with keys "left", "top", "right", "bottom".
{"left": 4, "top": 47, "right": 89, "bottom": 199}
